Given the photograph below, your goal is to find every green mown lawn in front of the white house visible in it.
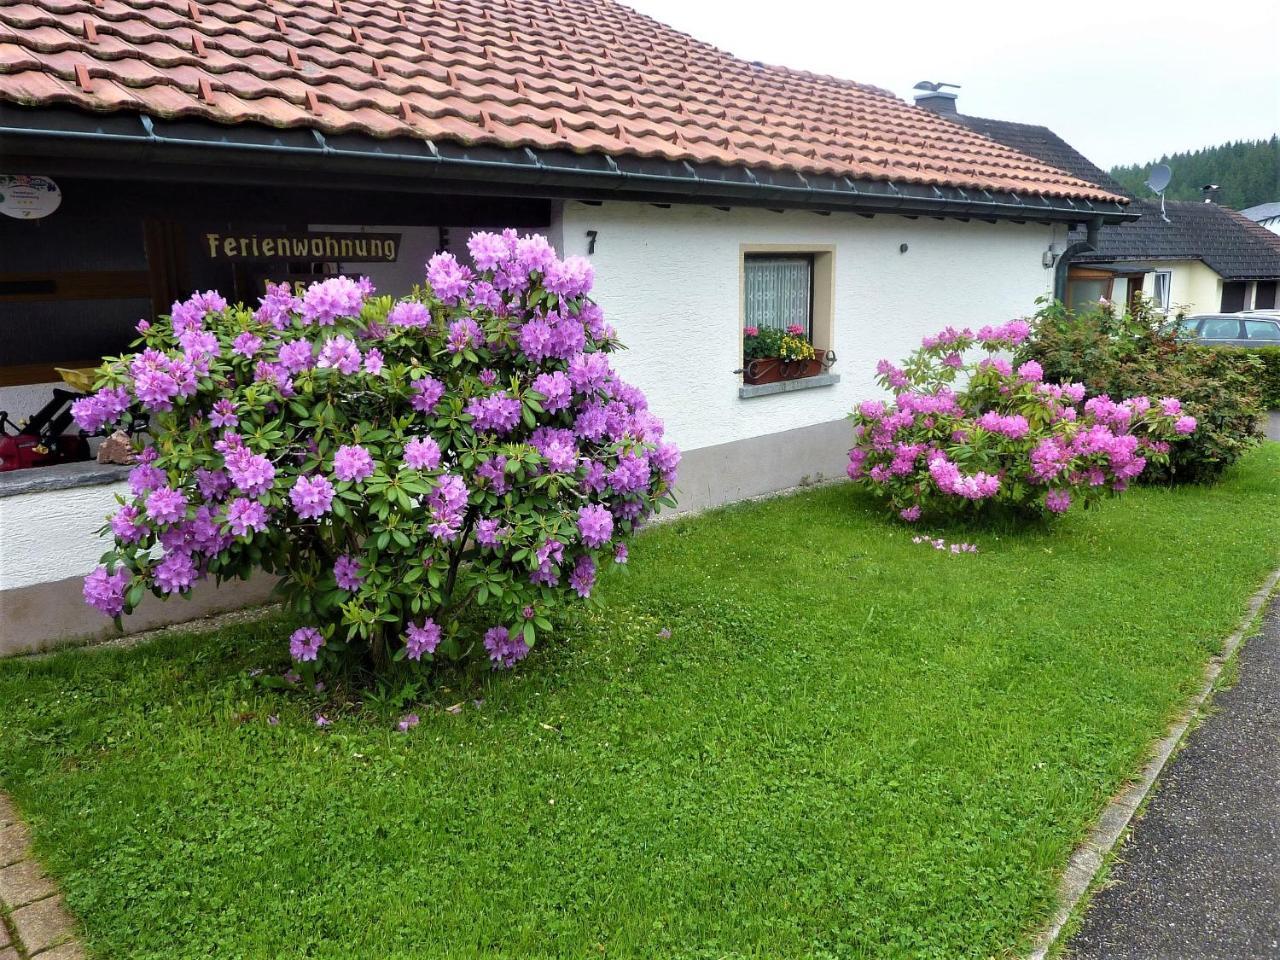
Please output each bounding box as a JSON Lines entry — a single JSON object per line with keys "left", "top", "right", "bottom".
{"left": 0, "top": 444, "right": 1280, "bottom": 960}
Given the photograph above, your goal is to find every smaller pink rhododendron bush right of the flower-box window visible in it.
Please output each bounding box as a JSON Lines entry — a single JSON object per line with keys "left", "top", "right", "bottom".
{"left": 849, "top": 320, "right": 1196, "bottom": 521}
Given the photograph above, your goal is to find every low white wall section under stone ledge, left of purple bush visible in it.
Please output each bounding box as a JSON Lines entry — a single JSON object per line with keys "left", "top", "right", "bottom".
{"left": 0, "top": 483, "right": 129, "bottom": 591}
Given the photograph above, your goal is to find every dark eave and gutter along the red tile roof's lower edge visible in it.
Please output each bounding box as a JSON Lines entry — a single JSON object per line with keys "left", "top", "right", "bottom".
{"left": 0, "top": 104, "right": 1138, "bottom": 223}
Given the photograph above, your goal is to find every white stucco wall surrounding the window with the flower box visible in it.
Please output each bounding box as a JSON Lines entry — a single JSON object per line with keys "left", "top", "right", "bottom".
{"left": 554, "top": 202, "right": 1065, "bottom": 449}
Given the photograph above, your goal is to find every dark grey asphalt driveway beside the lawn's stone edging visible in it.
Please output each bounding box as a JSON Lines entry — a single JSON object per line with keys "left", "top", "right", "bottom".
{"left": 1066, "top": 599, "right": 1280, "bottom": 960}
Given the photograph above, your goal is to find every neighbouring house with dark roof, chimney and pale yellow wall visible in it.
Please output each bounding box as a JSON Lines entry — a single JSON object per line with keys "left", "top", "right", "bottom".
{"left": 915, "top": 91, "right": 1280, "bottom": 315}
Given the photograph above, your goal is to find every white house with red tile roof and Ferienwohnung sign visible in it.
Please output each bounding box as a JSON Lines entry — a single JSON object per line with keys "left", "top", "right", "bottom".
{"left": 0, "top": 0, "right": 1133, "bottom": 646}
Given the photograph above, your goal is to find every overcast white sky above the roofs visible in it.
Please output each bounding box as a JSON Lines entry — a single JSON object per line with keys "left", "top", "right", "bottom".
{"left": 623, "top": 0, "right": 1280, "bottom": 168}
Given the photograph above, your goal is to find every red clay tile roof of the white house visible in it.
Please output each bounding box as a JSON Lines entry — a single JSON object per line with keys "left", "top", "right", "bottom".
{"left": 0, "top": 0, "right": 1124, "bottom": 202}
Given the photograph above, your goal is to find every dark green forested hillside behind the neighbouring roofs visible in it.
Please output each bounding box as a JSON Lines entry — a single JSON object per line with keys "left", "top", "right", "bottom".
{"left": 1111, "top": 136, "right": 1280, "bottom": 210}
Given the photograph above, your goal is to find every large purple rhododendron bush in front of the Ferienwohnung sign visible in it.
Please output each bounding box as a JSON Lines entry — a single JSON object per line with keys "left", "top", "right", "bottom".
{"left": 74, "top": 230, "right": 680, "bottom": 668}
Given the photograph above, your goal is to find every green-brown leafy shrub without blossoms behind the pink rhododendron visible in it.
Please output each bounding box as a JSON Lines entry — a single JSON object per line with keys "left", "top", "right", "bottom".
{"left": 1018, "top": 301, "right": 1262, "bottom": 483}
